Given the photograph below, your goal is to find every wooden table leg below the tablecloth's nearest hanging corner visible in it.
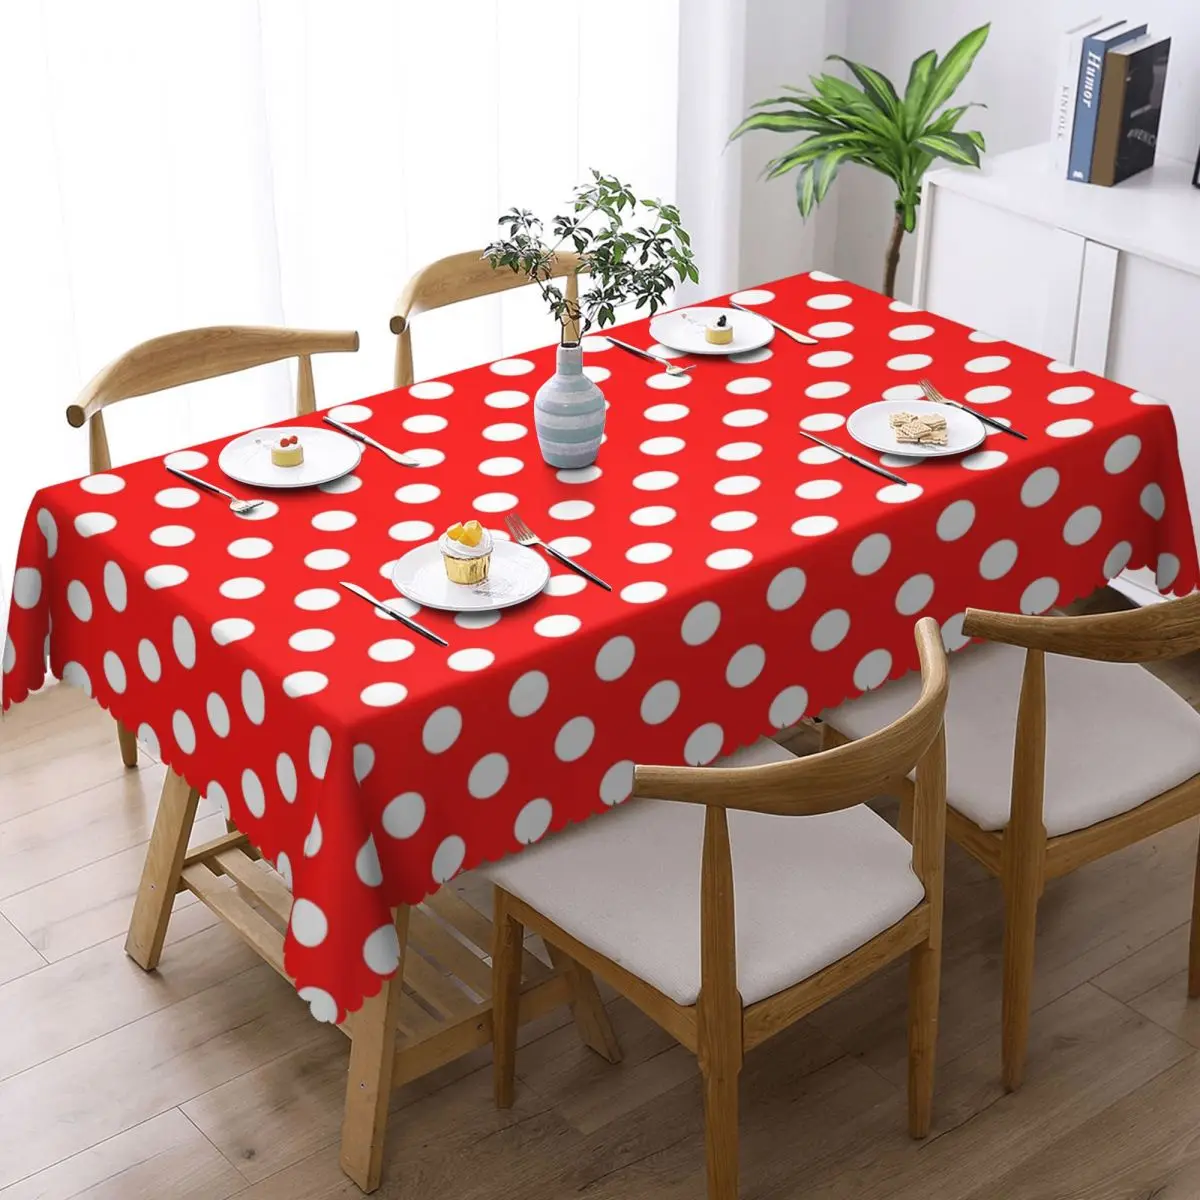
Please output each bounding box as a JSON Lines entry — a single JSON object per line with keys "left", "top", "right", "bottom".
{"left": 341, "top": 905, "right": 409, "bottom": 1192}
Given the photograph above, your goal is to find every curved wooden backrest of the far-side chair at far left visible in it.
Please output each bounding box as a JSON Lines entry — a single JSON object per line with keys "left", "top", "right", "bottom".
{"left": 67, "top": 325, "right": 359, "bottom": 473}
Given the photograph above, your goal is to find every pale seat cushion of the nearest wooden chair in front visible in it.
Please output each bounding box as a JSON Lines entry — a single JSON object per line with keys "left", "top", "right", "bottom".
{"left": 486, "top": 739, "right": 925, "bottom": 1004}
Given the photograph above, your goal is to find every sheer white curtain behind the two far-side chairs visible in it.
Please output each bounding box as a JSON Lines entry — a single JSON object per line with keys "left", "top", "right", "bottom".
{"left": 0, "top": 0, "right": 688, "bottom": 616}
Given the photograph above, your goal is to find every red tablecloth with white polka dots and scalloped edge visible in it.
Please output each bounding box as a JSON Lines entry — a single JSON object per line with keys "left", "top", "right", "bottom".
{"left": 4, "top": 272, "right": 1198, "bottom": 1020}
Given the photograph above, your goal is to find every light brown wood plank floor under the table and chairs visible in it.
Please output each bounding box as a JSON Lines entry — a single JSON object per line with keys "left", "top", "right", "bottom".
{"left": 7, "top": 585, "right": 1200, "bottom": 1200}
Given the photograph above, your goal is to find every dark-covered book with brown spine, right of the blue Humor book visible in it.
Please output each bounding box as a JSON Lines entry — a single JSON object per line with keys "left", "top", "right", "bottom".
{"left": 1092, "top": 36, "right": 1171, "bottom": 187}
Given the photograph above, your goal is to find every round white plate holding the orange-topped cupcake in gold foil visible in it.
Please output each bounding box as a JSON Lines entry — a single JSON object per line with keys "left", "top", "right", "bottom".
{"left": 391, "top": 538, "right": 550, "bottom": 612}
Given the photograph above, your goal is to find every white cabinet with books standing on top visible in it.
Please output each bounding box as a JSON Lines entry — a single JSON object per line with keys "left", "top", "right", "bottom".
{"left": 913, "top": 146, "right": 1200, "bottom": 602}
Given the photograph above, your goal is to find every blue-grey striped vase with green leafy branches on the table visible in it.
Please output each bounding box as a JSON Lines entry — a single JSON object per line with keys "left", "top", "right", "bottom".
{"left": 484, "top": 170, "right": 700, "bottom": 467}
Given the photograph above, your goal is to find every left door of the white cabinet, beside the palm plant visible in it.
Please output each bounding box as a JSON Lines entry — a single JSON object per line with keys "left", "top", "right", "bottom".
{"left": 914, "top": 185, "right": 1086, "bottom": 362}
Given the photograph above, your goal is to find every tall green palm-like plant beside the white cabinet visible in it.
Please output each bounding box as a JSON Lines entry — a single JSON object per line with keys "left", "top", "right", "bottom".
{"left": 730, "top": 25, "right": 991, "bottom": 296}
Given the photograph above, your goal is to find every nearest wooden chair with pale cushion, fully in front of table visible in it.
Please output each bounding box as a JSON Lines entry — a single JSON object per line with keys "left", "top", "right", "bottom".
{"left": 487, "top": 618, "right": 947, "bottom": 1200}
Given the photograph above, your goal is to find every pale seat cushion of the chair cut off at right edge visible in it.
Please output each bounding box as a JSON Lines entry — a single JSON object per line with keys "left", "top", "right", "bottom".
{"left": 823, "top": 644, "right": 1200, "bottom": 838}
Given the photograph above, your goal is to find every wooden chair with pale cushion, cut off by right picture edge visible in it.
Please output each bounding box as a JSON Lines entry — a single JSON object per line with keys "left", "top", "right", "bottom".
{"left": 823, "top": 594, "right": 1200, "bottom": 1091}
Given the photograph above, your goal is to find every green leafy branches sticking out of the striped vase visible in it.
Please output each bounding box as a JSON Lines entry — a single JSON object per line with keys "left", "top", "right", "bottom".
{"left": 484, "top": 170, "right": 700, "bottom": 346}
